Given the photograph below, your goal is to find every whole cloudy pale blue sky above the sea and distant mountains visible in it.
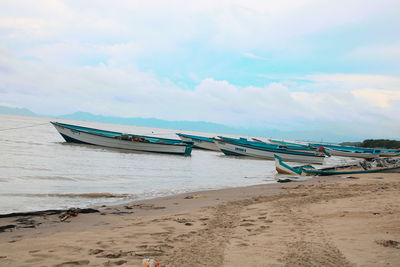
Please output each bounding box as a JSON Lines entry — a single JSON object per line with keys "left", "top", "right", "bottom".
{"left": 0, "top": 0, "right": 400, "bottom": 139}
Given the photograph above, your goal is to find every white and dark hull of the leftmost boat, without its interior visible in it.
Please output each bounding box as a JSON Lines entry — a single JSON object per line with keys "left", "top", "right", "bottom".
{"left": 53, "top": 123, "right": 191, "bottom": 155}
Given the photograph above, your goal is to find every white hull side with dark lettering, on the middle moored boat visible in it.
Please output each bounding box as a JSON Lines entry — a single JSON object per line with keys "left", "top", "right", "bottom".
{"left": 214, "top": 139, "right": 324, "bottom": 164}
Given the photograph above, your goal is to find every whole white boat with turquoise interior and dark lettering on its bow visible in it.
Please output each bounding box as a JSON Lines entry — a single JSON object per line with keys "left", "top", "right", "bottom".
{"left": 214, "top": 136, "right": 325, "bottom": 164}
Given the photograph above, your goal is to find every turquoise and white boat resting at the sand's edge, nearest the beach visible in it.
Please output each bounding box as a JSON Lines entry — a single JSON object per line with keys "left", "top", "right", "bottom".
{"left": 275, "top": 155, "right": 400, "bottom": 176}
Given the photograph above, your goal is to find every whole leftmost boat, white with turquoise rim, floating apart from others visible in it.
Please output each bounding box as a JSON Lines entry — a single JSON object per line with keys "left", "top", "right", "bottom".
{"left": 50, "top": 122, "right": 193, "bottom": 156}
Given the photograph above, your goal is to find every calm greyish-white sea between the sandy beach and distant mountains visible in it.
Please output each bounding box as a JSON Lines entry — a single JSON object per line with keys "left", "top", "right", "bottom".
{"left": 0, "top": 115, "right": 354, "bottom": 214}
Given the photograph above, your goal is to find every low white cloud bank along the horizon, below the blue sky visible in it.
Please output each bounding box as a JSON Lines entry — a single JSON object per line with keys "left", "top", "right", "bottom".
{"left": 0, "top": 48, "right": 400, "bottom": 135}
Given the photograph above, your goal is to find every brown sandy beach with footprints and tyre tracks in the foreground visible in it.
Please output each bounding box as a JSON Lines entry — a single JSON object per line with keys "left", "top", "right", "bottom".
{"left": 0, "top": 174, "right": 400, "bottom": 267}
